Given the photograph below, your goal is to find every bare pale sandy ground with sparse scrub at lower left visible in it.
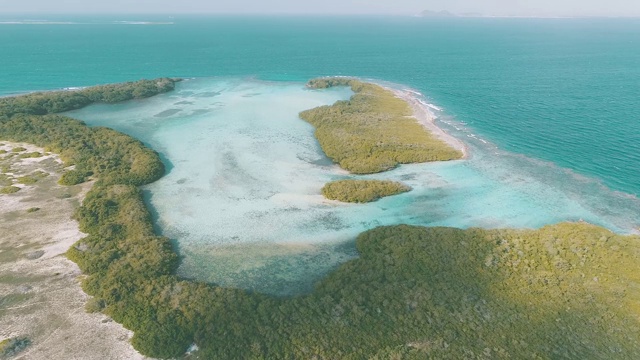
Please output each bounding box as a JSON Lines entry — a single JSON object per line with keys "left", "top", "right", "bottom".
{"left": 0, "top": 141, "right": 145, "bottom": 360}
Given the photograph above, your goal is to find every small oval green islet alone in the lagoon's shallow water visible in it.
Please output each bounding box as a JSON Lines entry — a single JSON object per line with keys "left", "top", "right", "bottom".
{"left": 322, "top": 179, "right": 411, "bottom": 203}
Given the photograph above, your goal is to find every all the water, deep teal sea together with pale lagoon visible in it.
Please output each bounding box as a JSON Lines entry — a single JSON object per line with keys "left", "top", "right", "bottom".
{"left": 0, "top": 15, "right": 640, "bottom": 293}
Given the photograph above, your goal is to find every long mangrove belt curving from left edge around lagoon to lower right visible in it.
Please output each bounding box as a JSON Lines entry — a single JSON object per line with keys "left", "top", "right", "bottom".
{"left": 0, "top": 77, "right": 640, "bottom": 359}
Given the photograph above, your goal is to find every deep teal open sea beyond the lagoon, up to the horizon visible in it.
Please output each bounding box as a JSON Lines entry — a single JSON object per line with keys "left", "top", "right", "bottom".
{"left": 0, "top": 15, "right": 640, "bottom": 195}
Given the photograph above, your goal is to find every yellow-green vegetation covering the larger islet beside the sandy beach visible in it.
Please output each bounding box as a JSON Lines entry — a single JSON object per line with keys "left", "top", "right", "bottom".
{"left": 300, "top": 78, "right": 462, "bottom": 174}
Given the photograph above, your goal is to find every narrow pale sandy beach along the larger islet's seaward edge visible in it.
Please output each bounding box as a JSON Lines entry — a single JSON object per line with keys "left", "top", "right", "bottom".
{"left": 388, "top": 85, "right": 469, "bottom": 159}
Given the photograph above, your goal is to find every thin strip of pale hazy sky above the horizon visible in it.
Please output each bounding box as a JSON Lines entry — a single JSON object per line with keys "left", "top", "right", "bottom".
{"left": 0, "top": 0, "right": 640, "bottom": 16}
